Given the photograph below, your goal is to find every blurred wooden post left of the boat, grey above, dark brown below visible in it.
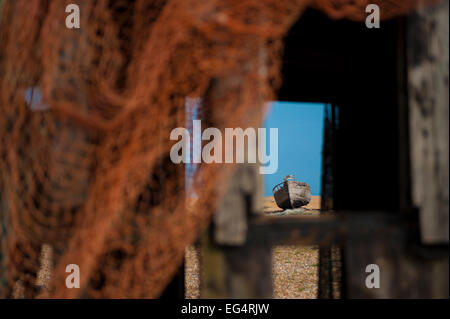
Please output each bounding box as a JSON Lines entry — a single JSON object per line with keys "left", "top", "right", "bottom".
{"left": 201, "top": 164, "right": 272, "bottom": 298}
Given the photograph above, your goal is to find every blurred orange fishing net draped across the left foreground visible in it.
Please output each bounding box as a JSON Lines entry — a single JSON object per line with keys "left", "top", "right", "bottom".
{"left": 0, "top": 0, "right": 442, "bottom": 298}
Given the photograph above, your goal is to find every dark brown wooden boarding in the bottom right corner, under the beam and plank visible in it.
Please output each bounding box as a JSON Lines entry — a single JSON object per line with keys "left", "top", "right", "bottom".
{"left": 344, "top": 231, "right": 449, "bottom": 298}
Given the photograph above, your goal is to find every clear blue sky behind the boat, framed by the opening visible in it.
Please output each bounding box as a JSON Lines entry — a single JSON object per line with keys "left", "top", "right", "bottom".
{"left": 263, "top": 102, "right": 325, "bottom": 196}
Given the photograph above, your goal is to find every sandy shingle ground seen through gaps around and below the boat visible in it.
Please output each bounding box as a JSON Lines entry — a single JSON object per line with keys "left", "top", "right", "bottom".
{"left": 186, "top": 196, "right": 320, "bottom": 299}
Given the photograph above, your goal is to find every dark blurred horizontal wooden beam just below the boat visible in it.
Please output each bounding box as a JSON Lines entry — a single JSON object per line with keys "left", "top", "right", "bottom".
{"left": 247, "top": 211, "right": 412, "bottom": 246}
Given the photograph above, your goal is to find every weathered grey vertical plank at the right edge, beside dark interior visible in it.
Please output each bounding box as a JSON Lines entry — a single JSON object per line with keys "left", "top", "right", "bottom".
{"left": 407, "top": 1, "right": 449, "bottom": 244}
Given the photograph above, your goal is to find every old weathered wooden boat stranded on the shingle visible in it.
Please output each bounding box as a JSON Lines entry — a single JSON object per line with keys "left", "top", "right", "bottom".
{"left": 272, "top": 175, "right": 311, "bottom": 209}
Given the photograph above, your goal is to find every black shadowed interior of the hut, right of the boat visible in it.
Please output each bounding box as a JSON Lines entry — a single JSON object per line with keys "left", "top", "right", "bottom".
{"left": 278, "top": 10, "right": 407, "bottom": 215}
